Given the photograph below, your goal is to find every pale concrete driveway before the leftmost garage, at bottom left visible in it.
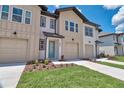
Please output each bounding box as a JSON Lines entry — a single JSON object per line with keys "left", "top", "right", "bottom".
{"left": 0, "top": 63, "right": 25, "bottom": 88}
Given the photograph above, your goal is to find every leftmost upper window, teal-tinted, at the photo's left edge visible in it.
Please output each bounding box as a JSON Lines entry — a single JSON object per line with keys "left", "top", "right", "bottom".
{"left": 1, "top": 5, "right": 9, "bottom": 20}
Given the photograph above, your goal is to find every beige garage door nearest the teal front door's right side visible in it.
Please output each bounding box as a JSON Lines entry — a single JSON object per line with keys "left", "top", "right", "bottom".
{"left": 65, "top": 43, "right": 79, "bottom": 59}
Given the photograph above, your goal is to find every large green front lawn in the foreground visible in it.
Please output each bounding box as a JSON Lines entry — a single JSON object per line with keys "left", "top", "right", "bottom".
{"left": 17, "top": 66, "right": 124, "bottom": 88}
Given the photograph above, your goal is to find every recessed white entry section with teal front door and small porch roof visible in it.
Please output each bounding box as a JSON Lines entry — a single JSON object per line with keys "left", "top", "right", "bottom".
{"left": 39, "top": 9, "right": 64, "bottom": 60}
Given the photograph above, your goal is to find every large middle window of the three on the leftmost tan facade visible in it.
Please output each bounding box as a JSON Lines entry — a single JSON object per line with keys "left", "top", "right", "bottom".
{"left": 12, "top": 8, "right": 22, "bottom": 23}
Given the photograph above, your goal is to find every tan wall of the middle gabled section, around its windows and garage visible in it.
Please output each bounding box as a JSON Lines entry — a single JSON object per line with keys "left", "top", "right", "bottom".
{"left": 58, "top": 10, "right": 83, "bottom": 58}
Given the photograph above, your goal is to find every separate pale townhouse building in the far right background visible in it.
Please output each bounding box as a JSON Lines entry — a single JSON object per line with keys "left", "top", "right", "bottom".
{"left": 99, "top": 33, "right": 124, "bottom": 56}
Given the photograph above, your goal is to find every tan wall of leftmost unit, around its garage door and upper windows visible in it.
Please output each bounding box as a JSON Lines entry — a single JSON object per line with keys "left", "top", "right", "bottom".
{"left": 0, "top": 5, "right": 41, "bottom": 61}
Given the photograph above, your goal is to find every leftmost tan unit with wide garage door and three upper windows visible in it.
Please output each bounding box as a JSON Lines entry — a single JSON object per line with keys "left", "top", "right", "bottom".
{"left": 0, "top": 5, "right": 41, "bottom": 63}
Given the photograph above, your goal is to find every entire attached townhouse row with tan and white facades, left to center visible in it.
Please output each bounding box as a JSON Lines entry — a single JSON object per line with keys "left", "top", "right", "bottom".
{"left": 0, "top": 5, "right": 101, "bottom": 63}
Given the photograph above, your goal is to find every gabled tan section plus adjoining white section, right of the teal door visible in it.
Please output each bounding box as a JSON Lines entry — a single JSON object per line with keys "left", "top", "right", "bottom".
{"left": 55, "top": 7, "right": 101, "bottom": 59}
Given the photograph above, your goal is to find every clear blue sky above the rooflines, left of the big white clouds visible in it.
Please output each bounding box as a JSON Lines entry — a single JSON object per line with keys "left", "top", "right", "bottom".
{"left": 48, "top": 5, "right": 120, "bottom": 32}
